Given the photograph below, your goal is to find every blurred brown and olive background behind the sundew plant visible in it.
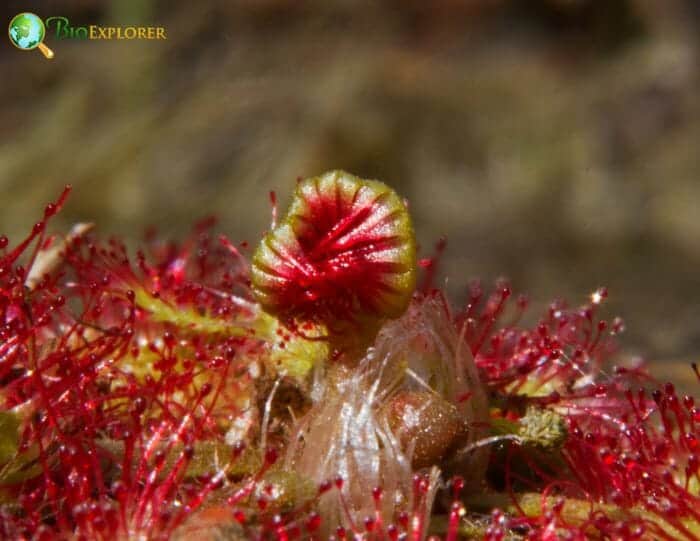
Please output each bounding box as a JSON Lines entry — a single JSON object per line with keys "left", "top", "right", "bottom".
{"left": 0, "top": 0, "right": 700, "bottom": 388}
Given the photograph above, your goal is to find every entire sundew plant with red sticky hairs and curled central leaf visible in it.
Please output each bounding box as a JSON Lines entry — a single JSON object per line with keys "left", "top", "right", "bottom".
{"left": 0, "top": 171, "right": 700, "bottom": 541}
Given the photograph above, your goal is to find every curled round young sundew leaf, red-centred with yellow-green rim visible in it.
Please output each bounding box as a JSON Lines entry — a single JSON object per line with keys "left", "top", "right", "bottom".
{"left": 252, "top": 171, "right": 416, "bottom": 323}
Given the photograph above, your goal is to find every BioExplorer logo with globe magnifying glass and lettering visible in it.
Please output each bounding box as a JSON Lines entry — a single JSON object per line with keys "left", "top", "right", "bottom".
{"left": 7, "top": 12, "right": 168, "bottom": 59}
